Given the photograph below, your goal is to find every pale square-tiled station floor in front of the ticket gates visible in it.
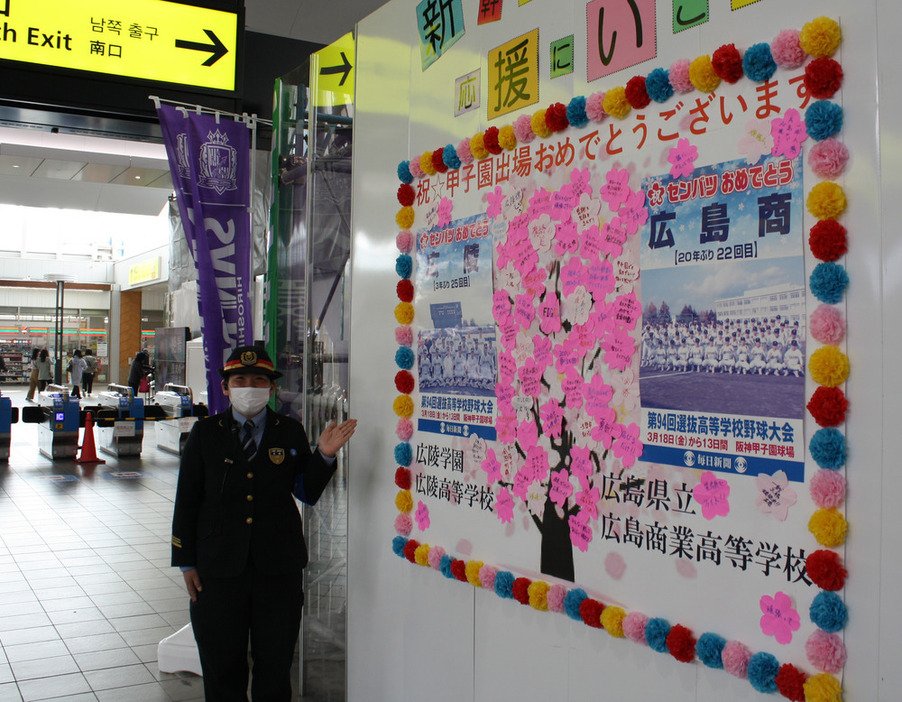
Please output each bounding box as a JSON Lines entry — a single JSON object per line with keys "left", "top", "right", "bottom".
{"left": 0, "top": 387, "right": 203, "bottom": 702}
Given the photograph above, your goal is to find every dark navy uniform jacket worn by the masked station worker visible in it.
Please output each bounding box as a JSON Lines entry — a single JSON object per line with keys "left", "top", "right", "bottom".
{"left": 172, "top": 408, "right": 334, "bottom": 580}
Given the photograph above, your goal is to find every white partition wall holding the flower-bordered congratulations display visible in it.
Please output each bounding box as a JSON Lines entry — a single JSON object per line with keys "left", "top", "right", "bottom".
{"left": 348, "top": 0, "right": 902, "bottom": 702}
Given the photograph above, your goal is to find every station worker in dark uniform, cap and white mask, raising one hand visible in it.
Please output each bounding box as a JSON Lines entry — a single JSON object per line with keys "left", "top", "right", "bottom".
{"left": 172, "top": 346, "right": 357, "bottom": 702}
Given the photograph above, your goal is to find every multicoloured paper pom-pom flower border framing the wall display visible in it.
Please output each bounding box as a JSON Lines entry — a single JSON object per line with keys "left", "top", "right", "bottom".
{"left": 392, "top": 17, "right": 848, "bottom": 702}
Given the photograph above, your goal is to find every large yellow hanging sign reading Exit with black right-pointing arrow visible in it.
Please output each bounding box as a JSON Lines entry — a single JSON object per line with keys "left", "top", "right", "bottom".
{"left": 0, "top": 0, "right": 238, "bottom": 90}
